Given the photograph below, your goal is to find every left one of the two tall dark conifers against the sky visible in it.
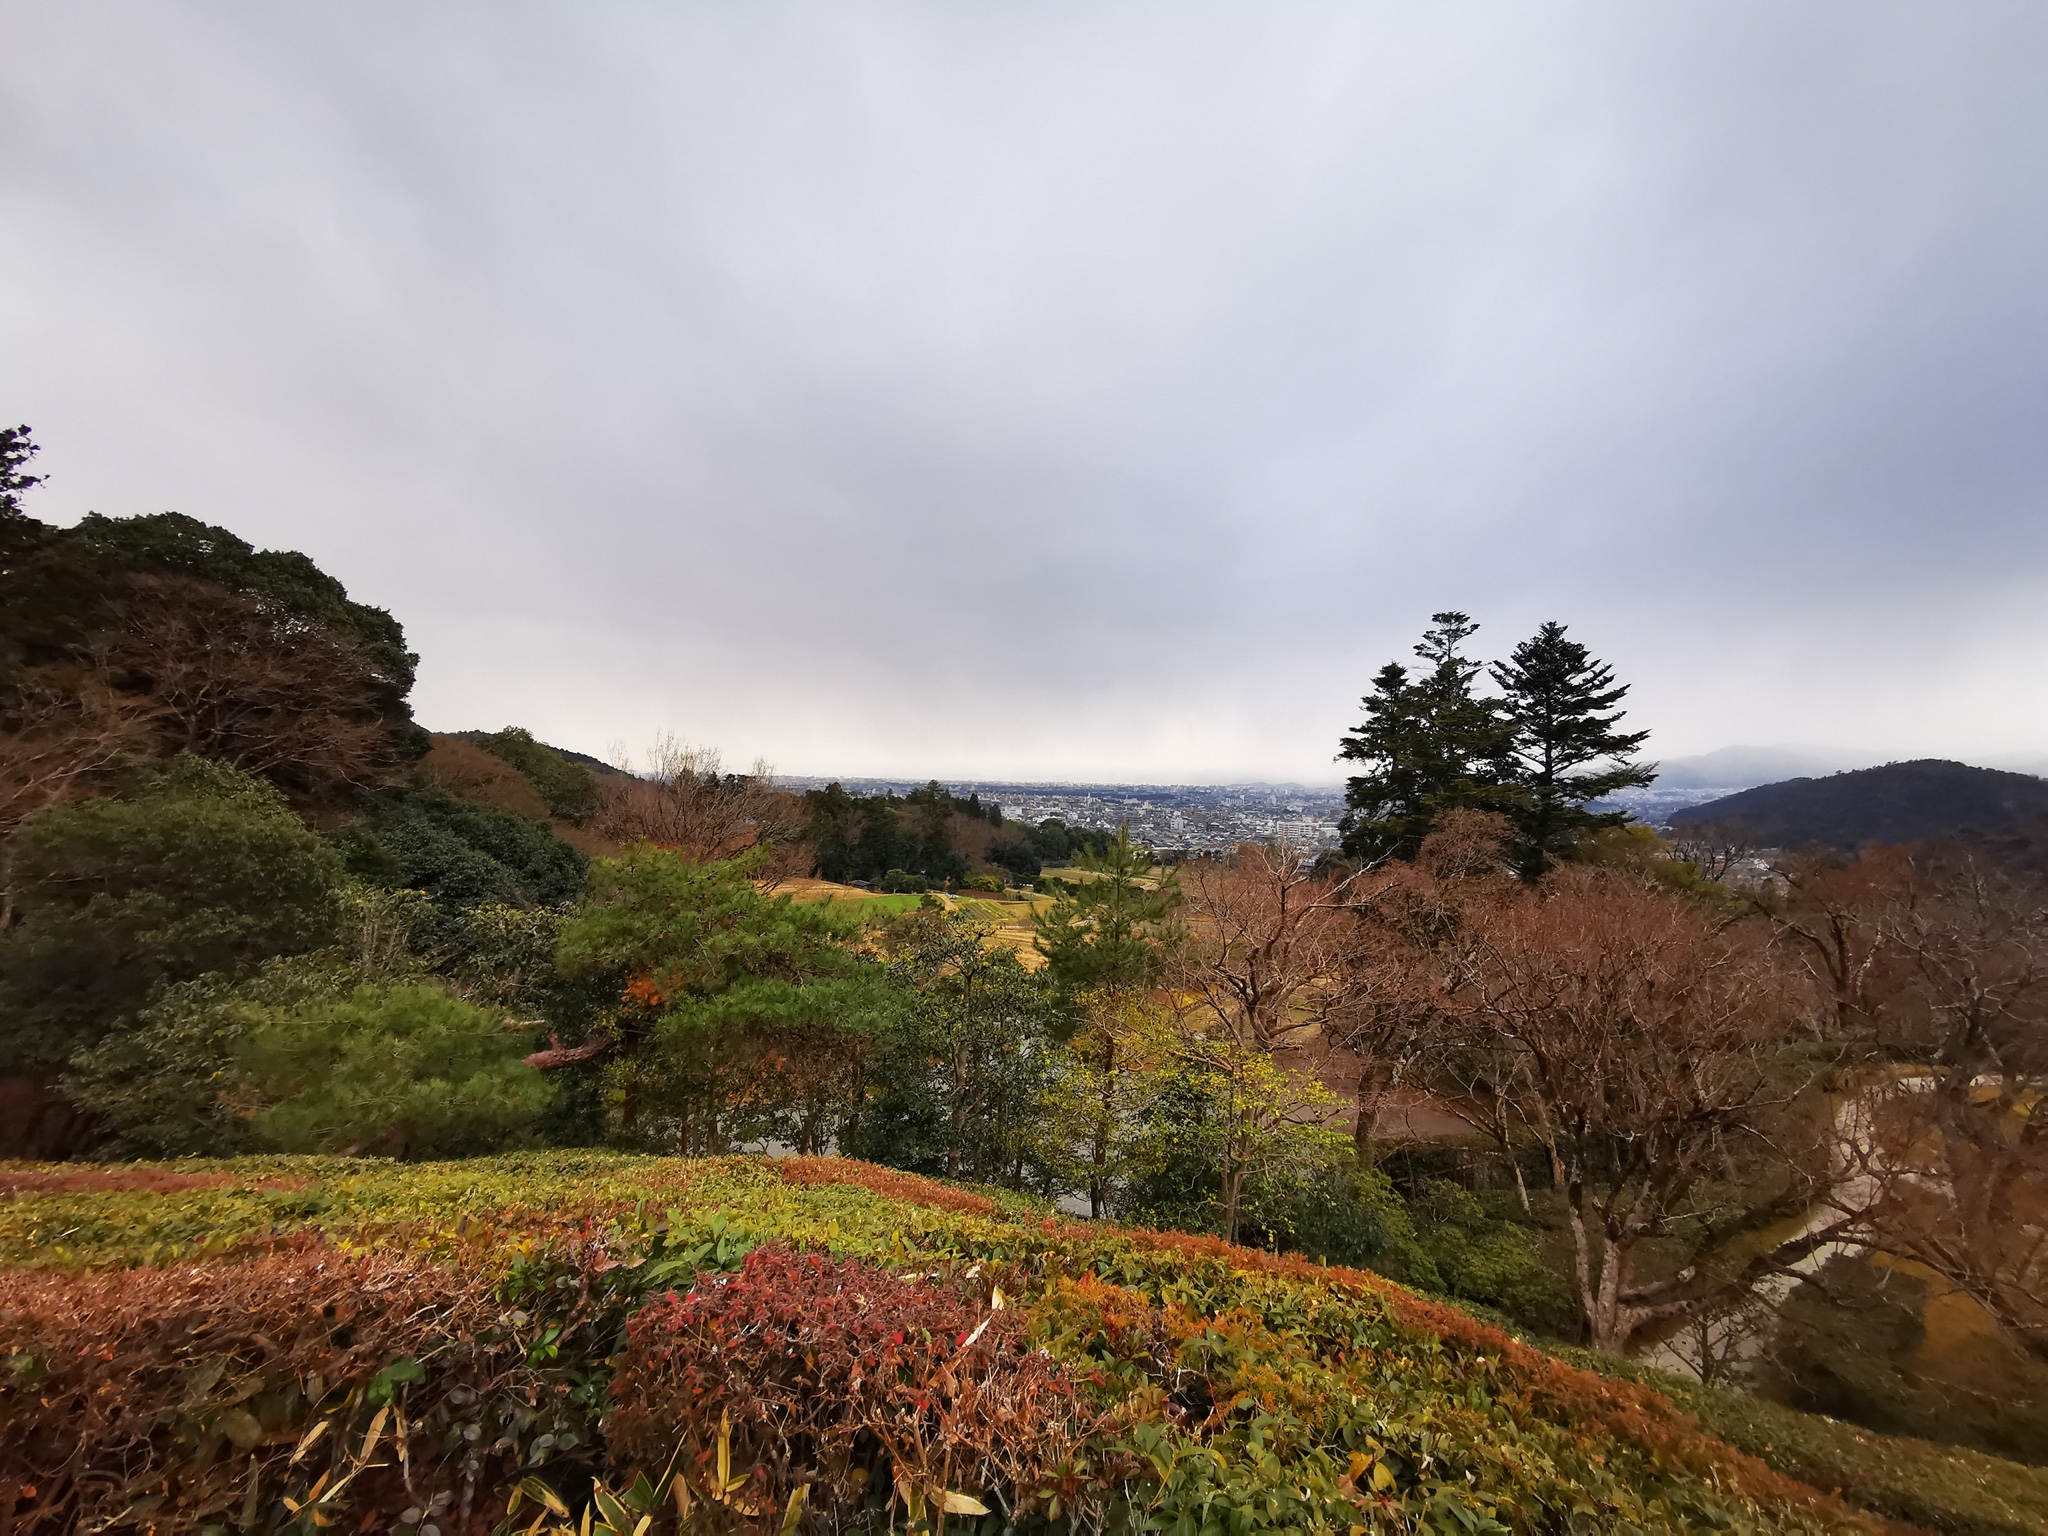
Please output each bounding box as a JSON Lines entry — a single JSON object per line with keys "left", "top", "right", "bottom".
{"left": 1337, "top": 612, "right": 1520, "bottom": 862}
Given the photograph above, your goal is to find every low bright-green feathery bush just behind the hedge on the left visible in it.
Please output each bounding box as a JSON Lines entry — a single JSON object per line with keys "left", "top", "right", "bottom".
{"left": 236, "top": 983, "right": 555, "bottom": 1157}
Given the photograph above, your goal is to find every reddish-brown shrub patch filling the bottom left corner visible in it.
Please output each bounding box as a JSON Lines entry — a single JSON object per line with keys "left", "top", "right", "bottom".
{"left": 0, "top": 1243, "right": 539, "bottom": 1532}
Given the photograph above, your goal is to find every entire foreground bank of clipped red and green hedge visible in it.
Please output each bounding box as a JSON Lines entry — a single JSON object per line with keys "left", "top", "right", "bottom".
{"left": 0, "top": 1153, "right": 2040, "bottom": 1536}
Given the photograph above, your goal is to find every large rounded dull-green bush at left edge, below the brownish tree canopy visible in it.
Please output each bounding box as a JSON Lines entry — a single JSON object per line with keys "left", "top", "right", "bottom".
{"left": 0, "top": 758, "right": 344, "bottom": 1063}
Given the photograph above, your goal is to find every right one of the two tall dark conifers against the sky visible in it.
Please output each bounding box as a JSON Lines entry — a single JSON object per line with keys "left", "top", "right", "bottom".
{"left": 1493, "top": 623, "right": 1657, "bottom": 881}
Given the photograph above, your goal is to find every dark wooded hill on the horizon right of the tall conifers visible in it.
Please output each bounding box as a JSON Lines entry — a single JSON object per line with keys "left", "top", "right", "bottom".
{"left": 1671, "top": 758, "right": 2048, "bottom": 850}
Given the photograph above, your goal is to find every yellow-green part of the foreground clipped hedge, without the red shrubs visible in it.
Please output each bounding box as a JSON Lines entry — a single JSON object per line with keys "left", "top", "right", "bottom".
{"left": 0, "top": 1153, "right": 2044, "bottom": 1534}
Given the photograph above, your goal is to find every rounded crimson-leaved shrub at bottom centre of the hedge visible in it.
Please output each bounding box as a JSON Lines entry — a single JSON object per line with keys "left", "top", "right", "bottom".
{"left": 606, "top": 1247, "right": 1096, "bottom": 1522}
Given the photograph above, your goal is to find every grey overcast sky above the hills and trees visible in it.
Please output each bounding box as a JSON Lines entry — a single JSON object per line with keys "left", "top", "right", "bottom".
{"left": 0, "top": 0, "right": 2048, "bottom": 780}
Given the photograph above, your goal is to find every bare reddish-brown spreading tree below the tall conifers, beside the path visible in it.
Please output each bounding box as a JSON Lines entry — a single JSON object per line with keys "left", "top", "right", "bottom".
{"left": 1421, "top": 868, "right": 1847, "bottom": 1350}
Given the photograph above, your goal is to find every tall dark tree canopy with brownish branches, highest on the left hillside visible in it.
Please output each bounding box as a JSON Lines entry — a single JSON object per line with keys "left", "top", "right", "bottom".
{"left": 0, "top": 438, "right": 428, "bottom": 821}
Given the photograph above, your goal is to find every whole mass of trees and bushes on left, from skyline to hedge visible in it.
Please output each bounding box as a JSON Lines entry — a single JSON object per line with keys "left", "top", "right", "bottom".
{"left": 0, "top": 428, "right": 596, "bottom": 1155}
